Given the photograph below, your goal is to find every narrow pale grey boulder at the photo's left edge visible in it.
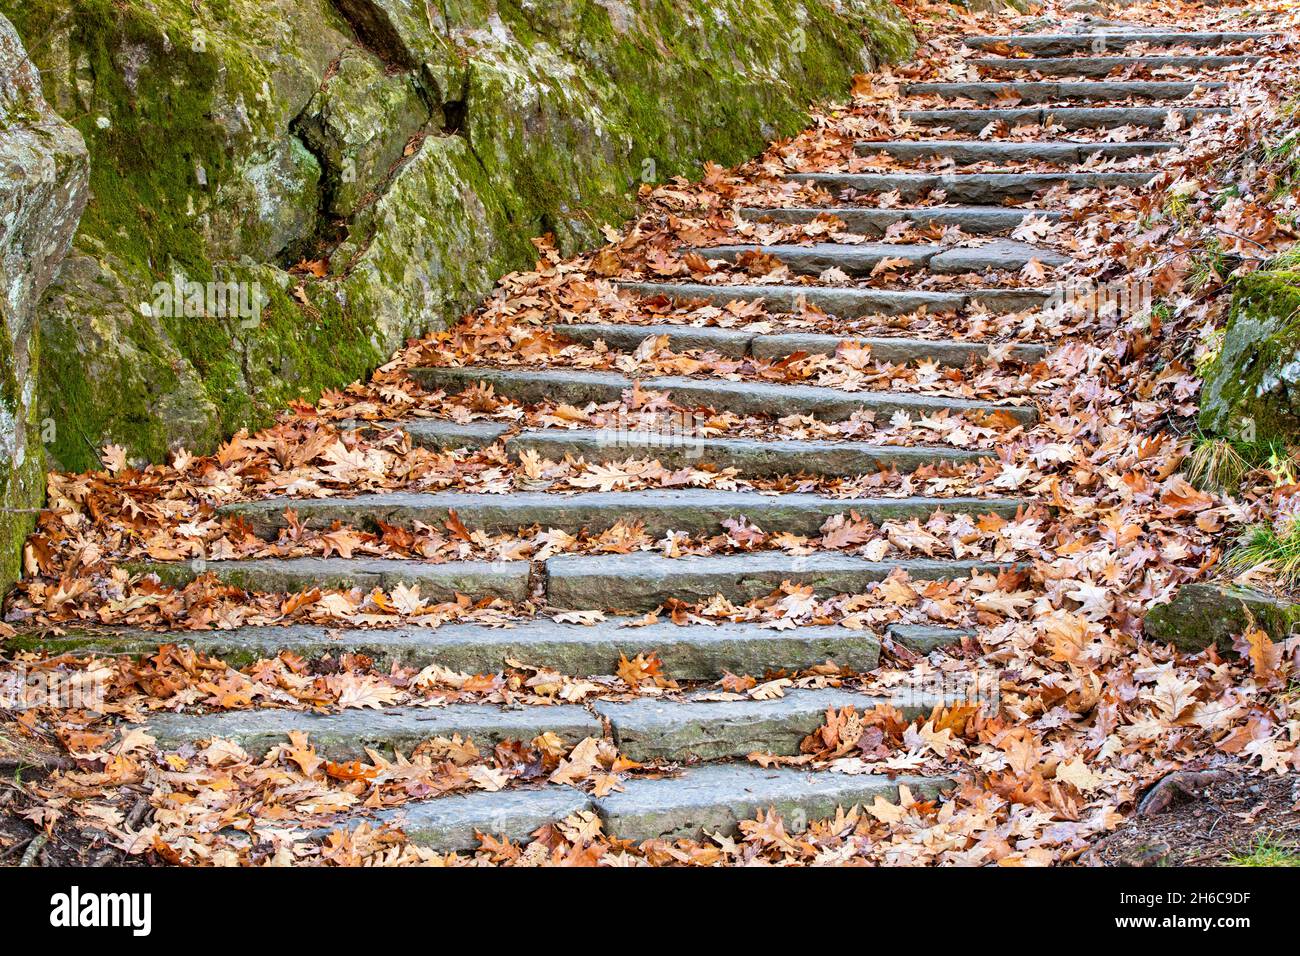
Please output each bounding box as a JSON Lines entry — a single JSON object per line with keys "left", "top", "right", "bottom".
{"left": 0, "top": 17, "right": 90, "bottom": 593}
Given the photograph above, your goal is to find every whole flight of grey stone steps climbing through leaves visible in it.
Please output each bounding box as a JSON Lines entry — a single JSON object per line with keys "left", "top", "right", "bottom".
{"left": 35, "top": 16, "right": 1274, "bottom": 849}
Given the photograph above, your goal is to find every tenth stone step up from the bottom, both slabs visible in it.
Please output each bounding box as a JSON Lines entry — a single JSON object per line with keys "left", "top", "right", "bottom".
{"left": 696, "top": 240, "right": 1066, "bottom": 276}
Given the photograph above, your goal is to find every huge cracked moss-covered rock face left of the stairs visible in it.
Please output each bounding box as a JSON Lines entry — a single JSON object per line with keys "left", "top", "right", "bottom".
{"left": 0, "top": 0, "right": 913, "bottom": 468}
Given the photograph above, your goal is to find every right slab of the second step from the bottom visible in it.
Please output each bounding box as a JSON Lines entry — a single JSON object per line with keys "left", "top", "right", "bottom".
{"left": 594, "top": 674, "right": 940, "bottom": 762}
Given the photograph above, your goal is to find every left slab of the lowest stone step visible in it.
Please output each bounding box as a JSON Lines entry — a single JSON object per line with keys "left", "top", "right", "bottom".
{"left": 351, "top": 787, "right": 593, "bottom": 853}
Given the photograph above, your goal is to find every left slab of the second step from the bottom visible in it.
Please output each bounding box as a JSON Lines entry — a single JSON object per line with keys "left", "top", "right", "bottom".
{"left": 144, "top": 704, "right": 605, "bottom": 761}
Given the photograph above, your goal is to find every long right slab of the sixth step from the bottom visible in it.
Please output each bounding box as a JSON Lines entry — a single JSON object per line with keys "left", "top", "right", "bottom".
{"left": 506, "top": 428, "right": 993, "bottom": 477}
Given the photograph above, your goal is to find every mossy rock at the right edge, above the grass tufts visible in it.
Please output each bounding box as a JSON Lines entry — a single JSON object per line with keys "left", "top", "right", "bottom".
{"left": 1201, "top": 269, "right": 1300, "bottom": 445}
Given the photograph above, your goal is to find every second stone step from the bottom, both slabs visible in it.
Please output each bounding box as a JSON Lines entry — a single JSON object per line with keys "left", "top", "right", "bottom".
{"left": 144, "top": 675, "right": 958, "bottom": 762}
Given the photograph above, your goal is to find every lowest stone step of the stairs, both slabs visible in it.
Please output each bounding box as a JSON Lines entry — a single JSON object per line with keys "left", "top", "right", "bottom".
{"left": 327, "top": 763, "right": 954, "bottom": 852}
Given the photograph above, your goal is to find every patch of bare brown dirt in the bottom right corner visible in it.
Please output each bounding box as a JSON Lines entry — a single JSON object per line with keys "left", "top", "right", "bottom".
{"left": 1080, "top": 775, "right": 1300, "bottom": 866}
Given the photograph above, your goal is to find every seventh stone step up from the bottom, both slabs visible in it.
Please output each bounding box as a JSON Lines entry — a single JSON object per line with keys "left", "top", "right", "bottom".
{"left": 411, "top": 367, "right": 1037, "bottom": 423}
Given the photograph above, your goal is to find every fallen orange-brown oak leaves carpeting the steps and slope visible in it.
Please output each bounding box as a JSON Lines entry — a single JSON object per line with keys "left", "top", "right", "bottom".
{"left": 0, "top": 3, "right": 1300, "bottom": 865}
